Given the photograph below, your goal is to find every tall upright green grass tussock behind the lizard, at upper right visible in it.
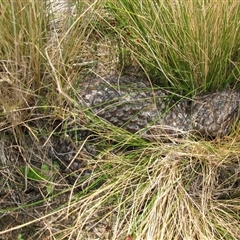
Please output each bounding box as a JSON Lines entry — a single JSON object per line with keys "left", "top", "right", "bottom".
{"left": 108, "top": 0, "right": 240, "bottom": 93}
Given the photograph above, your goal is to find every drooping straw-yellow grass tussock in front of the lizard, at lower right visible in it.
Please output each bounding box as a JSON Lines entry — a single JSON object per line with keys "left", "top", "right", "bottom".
{"left": 22, "top": 133, "right": 240, "bottom": 239}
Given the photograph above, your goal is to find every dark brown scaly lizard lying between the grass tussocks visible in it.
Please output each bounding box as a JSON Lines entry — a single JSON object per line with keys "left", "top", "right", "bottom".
{"left": 80, "top": 76, "right": 240, "bottom": 137}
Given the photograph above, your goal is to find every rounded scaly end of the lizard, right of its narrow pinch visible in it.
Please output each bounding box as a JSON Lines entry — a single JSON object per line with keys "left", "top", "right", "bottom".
{"left": 192, "top": 90, "right": 240, "bottom": 137}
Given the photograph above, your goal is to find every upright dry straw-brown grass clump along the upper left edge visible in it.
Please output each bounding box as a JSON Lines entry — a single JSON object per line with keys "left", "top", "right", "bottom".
{"left": 0, "top": 1, "right": 47, "bottom": 131}
